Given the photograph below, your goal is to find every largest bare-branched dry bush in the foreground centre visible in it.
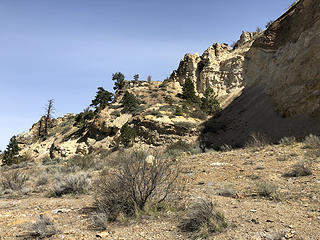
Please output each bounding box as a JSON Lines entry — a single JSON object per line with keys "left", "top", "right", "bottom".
{"left": 95, "top": 150, "right": 178, "bottom": 221}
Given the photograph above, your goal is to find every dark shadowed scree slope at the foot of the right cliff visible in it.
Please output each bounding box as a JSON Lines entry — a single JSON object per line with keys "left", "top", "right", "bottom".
{"left": 199, "top": 86, "right": 320, "bottom": 149}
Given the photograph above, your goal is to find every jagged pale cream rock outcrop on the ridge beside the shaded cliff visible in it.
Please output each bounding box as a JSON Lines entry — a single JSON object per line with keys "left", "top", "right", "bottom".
{"left": 170, "top": 31, "right": 256, "bottom": 98}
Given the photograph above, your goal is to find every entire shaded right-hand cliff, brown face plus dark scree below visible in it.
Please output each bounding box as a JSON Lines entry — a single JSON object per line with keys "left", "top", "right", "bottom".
{"left": 201, "top": 0, "right": 320, "bottom": 148}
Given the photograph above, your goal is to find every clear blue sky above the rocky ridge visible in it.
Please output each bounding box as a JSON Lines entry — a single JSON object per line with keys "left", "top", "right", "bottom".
{"left": 0, "top": 0, "right": 293, "bottom": 150}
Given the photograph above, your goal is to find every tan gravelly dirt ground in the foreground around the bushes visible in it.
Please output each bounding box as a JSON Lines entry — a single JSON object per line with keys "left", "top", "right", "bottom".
{"left": 0, "top": 143, "right": 320, "bottom": 240}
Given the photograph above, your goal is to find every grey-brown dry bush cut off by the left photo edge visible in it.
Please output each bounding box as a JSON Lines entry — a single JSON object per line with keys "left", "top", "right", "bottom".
{"left": 0, "top": 170, "right": 29, "bottom": 191}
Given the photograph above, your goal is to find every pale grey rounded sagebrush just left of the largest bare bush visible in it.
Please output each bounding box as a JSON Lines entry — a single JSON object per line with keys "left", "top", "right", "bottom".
{"left": 49, "top": 173, "right": 90, "bottom": 197}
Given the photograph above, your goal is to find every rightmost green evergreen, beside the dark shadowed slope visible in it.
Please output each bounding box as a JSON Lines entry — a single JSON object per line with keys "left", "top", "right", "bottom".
{"left": 201, "top": 87, "right": 221, "bottom": 115}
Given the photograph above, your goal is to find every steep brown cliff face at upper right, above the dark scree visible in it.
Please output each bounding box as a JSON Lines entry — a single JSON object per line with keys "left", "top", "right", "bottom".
{"left": 244, "top": 0, "right": 320, "bottom": 117}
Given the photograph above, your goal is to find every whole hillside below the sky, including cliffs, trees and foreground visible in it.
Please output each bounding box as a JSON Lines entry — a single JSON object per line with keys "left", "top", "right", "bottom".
{"left": 0, "top": 0, "right": 320, "bottom": 240}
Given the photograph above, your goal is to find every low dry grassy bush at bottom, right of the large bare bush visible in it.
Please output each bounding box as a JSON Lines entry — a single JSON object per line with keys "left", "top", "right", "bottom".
{"left": 179, "top": 199, "right": 227, "bottom": 238}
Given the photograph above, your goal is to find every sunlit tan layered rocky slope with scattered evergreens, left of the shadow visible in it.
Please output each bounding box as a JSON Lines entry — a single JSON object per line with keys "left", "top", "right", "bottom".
{"left": 17, "top": 81, "right": 203, "bottom": 160}
